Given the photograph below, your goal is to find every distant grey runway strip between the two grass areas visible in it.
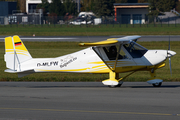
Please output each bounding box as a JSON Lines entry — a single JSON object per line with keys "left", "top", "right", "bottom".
{"left": 0, "top": 35, "right": 180, "bottom": 42}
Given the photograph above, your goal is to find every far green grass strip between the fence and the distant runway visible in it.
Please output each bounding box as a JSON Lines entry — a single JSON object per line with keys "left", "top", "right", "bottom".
{"left": 0, "top": 24, "right": 180, "bottom": 36}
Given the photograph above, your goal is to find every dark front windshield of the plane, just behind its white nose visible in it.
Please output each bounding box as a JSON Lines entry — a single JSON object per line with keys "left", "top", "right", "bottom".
{"left": 123, "top": 41, "right": 147, "bottom": 58}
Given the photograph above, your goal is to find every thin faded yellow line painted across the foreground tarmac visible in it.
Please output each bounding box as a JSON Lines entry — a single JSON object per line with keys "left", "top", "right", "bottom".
{"left": 0, "top": 108, "right": 180, "bottom": 116}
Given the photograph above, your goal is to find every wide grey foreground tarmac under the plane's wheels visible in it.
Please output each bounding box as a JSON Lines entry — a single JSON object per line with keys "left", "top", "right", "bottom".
{"left": 0, "top": 82, "right": 180, "bottom": 120}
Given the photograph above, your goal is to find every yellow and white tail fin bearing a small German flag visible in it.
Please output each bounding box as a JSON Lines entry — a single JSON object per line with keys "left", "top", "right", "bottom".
{"left": 4, "top": 36, "right": 32, "bottom": 71}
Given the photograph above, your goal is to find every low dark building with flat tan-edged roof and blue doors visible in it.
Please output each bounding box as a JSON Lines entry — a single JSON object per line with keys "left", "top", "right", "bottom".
{"left": 114, "top": 3, "right": 149, "bottom": 24}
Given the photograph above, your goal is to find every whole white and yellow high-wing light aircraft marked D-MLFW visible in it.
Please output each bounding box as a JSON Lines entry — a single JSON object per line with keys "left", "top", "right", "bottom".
{"left": 4, "top": 36, "right": 176, "bottom": 87}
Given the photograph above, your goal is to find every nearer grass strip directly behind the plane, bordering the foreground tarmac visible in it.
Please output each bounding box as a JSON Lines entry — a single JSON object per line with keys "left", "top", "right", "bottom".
{"left": 0, "top": 42, "right": 180, "bottom": 81}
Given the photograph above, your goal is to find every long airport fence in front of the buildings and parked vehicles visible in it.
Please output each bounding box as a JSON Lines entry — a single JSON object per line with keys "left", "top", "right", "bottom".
{"left": 0, "top": 14, "right": 180, "bottom": 27}
